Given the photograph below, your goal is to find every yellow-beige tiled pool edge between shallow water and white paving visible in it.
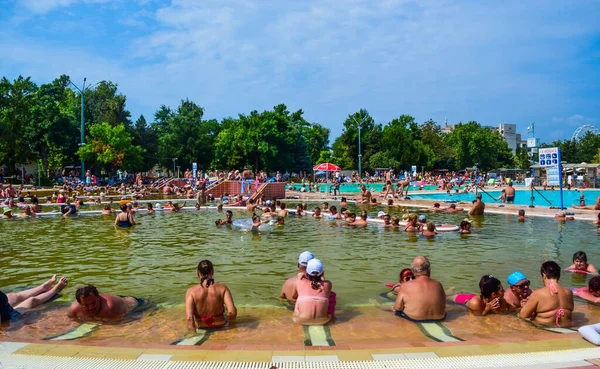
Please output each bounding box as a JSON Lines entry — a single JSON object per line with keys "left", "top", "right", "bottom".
{"left": 0, "top": 335, "right": 600, "bottom": 362}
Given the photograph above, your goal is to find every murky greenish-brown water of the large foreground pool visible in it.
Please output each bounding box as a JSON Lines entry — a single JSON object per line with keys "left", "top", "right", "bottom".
{"left": 0, "top": 203, "right": 600, "bottom": 344}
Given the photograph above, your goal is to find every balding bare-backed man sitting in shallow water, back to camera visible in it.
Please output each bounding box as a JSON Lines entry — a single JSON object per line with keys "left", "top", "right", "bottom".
{"left": 394, "top": 256, "right": 446, "bottom": 321}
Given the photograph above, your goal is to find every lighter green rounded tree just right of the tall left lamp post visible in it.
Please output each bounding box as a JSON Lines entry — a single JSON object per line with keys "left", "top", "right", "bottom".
{"left": 77, "top": 123, "right": 144, "bottom": 172}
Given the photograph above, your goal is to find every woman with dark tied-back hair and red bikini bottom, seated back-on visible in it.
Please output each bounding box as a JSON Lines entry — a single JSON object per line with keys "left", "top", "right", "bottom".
{"left": 185, "top": 260, "right": 237, "bottom": 332}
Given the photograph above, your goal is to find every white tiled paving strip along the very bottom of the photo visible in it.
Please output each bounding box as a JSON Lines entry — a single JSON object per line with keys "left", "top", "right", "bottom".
{"left": 0, "top": 345, "right": 600, "bottom": 369}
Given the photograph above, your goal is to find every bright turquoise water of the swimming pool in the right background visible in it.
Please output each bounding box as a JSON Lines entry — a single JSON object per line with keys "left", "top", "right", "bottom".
{"left": 410, "top": 189, "right": 600, "bottom": 208}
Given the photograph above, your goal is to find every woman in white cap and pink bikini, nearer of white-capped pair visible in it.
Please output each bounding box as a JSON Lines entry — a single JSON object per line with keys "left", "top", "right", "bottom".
{"left": 293, "top": 259, "right": 335, "bottom": 325}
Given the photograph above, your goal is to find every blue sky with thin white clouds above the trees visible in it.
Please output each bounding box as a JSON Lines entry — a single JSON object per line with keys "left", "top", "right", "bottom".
{"left": 0, "top": 0, "right": 600, "bottom": 141}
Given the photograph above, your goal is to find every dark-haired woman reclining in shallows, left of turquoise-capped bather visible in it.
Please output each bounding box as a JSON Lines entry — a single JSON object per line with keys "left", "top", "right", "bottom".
{"left": 454, "top": 275, "right": 513, "bottom": 315}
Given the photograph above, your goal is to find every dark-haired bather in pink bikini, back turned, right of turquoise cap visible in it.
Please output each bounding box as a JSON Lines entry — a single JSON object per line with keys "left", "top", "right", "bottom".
{"left": 519, "top": 261, "right": 574, "bottom": 327}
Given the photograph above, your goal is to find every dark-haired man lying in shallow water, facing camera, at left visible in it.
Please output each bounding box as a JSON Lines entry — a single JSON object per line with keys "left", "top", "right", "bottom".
{"left": 67, "top": 285, "right": 143, "bottom": 321}
